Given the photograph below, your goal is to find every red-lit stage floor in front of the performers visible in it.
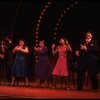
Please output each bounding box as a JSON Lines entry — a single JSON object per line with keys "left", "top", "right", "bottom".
{"left": 0, "top": 82, "right": 100, "bottom": 99}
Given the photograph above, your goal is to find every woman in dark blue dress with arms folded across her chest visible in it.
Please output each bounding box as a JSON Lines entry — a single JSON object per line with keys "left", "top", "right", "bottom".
{"left": 11, "top": 40, "right": 29, "bottom": 86}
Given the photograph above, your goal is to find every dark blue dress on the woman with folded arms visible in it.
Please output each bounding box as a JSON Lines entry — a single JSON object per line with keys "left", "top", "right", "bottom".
{"left": 12, "top": 51, "right": 28, "bottom": 77}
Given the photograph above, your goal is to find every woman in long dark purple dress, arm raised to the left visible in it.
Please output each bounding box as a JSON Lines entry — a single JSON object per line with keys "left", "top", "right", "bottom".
{"left": 34, "top": 40, "right": 50, "bottom": 87}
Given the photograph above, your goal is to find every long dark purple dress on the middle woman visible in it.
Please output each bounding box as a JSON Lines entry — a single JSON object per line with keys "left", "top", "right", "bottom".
{"left": 35, "top": 46, "right": 50, "bottom": 80}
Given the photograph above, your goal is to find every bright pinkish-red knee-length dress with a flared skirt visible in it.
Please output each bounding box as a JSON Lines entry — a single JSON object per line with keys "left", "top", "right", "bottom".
{"left": 52, "top": 46, "right": 68, "bottom": 76}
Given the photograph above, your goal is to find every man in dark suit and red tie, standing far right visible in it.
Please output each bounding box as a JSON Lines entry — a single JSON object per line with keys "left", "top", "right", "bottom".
{"left": 76, "top": 32, "right": 98, "bottom": 91}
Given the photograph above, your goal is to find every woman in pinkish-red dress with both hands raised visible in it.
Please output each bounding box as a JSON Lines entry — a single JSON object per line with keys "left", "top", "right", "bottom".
{"left": 52, "top": 38, "right": 72, "bottom": 88}
